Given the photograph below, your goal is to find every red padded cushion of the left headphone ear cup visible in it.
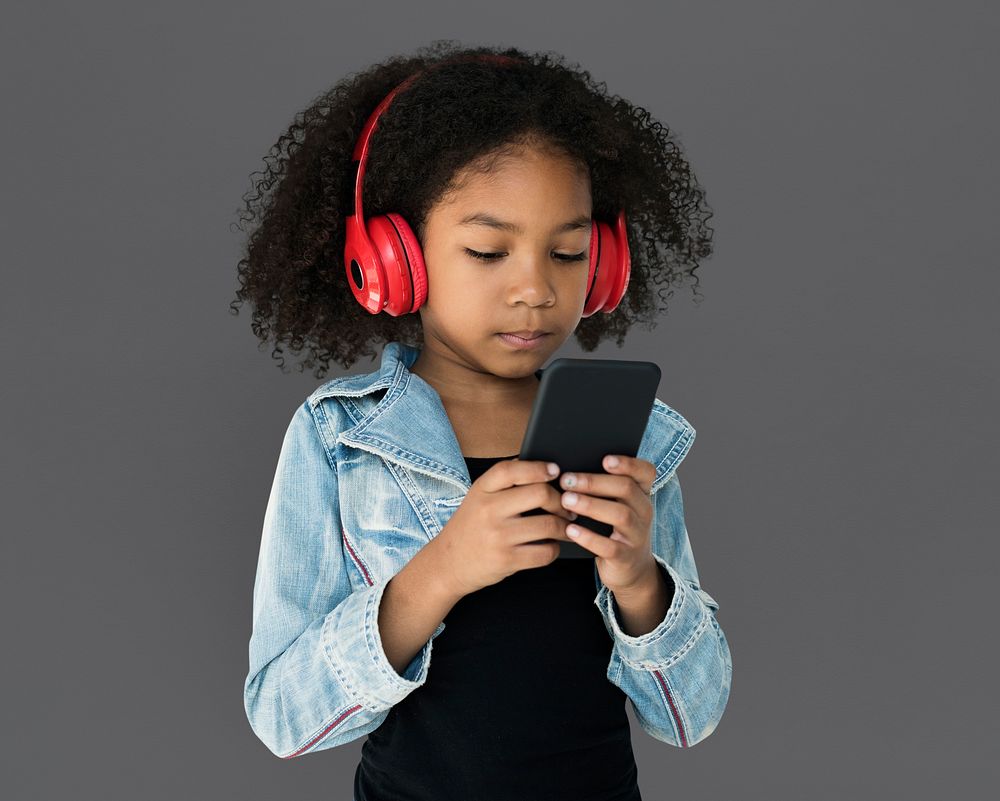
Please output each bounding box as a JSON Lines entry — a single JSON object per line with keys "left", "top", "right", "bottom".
{"left": 368, "top": 214, "right": 427, "bottom": 317}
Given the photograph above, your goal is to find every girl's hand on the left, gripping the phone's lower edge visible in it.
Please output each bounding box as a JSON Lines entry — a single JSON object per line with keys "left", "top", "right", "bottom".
{"left": 429, "top": 459, "right": 576, "bottom": 598}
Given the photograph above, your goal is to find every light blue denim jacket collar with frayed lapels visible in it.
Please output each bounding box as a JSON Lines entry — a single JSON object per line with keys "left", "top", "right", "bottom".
{"left": 309, "top": 342, "right": 695, "bottom": 492}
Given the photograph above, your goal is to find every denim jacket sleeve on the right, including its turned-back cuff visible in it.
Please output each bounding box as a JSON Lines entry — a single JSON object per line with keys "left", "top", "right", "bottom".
{"left": 594, "top": 470, "right": 733, "bottom": 748}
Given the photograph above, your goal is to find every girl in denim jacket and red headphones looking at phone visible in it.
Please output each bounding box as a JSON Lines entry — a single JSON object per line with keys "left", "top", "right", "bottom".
{"left": 238, "top": 41, "right": 732, "bottom": 801}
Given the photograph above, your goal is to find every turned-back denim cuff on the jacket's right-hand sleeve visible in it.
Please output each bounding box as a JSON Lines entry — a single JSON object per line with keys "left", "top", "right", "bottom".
{"left": 594, "top": 553, "right": 710, "bottom": 670}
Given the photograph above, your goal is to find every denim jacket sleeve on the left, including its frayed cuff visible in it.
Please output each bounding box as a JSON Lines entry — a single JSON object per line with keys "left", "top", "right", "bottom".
{"left": 243, "top": 401, "right": 444, "bottom": 758}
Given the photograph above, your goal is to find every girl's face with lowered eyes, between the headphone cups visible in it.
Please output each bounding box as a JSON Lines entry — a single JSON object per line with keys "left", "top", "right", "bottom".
{"left": 420, "top": 141, "right": 592, "bottom": 388}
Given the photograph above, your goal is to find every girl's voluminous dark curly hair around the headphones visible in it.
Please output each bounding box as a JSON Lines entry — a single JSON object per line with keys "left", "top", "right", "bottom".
{"left": 230, "top": 39, "right": 712, "bottom": 378}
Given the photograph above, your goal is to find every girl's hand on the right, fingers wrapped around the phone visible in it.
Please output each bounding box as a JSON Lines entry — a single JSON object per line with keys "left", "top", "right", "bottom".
{"left": 559, "top": 454, "right": 657, "bottom": 596}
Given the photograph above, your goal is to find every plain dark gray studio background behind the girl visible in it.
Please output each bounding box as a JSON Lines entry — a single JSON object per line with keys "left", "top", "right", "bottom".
{"left": 0, "top": 2, "right": 1000, "bottom": 801}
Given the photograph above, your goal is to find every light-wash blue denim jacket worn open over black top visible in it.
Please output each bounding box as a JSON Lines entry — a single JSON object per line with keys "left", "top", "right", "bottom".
{"left": 243, "top": 342, "right": 732, "bottom": 758}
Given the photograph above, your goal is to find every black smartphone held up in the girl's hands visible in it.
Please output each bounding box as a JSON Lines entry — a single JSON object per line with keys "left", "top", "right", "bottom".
{"left": 518, "top": 358, "right": 660, "bottom": 559}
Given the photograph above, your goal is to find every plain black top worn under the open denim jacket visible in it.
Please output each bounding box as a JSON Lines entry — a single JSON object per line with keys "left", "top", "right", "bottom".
{"left": 354, "top": 455, "right": 642, "bottom": 801}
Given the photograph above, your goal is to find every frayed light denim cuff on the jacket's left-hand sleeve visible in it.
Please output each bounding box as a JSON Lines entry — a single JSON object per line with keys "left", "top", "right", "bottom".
{"left": 321, "top": 579, "right": 445, "bottom": 710}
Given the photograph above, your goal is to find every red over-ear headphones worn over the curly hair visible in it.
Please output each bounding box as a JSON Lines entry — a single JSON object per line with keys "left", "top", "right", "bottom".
{"left": 344, "top": 55, "right": 632, "bottom": 317}
